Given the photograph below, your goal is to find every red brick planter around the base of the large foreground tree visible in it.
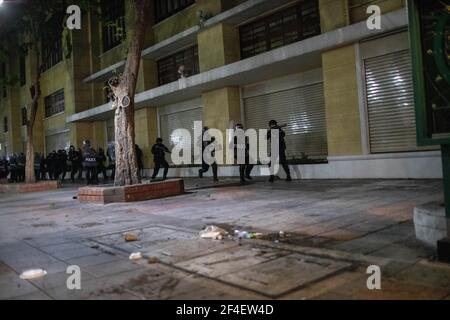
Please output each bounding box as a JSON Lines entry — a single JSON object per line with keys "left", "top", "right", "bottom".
{"left": 78, "top": 179, "right": 184, "bottom": 204}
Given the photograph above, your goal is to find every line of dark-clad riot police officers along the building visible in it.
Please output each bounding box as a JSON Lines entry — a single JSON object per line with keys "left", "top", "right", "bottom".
{"left": 0, "top": 120, "right": 292, "bottom": 185}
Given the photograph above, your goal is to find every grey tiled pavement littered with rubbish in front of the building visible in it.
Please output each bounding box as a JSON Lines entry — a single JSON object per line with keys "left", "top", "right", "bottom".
{"left": 0, "top": 179, "right": 450, "bottom": 299}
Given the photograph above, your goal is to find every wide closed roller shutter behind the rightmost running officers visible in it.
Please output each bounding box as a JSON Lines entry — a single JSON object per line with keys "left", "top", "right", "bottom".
{"left": 244, "top": 83, "right": 328, "bottom": 158}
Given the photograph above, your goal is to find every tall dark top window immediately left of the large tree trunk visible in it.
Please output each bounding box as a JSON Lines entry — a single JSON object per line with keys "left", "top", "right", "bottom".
{"left": 101, "top": 0, "right": 126, "bottom": 52}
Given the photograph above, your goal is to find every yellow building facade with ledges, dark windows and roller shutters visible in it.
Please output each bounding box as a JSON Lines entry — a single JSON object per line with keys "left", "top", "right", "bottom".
{"left": 0, "top": 0, "right": 442, "bottom": 179}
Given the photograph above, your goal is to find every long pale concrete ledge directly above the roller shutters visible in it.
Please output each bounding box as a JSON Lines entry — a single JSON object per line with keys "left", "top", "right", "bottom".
{"left": 67, "top": 9, "right": 408, "bottom": 122}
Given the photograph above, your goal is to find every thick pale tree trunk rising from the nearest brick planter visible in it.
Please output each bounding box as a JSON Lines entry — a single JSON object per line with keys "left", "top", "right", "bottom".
{"left": 110, "top": 0, "right": 151, "bottom": 186}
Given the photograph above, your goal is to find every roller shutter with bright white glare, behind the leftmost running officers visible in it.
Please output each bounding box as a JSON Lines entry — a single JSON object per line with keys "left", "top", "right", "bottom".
{"left": 160, "top": 108, "right": 202, "bottom": 162}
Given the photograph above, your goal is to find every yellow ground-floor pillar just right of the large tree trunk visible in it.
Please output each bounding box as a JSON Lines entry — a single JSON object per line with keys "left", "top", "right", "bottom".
{"left": 134, "top": 108, "right": 158, "bottom": 168}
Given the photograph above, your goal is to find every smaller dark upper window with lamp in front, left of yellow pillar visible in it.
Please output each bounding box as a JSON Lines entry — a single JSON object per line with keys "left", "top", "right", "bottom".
{"left": 158, "top": 46, "right": 199, "bottom": 86}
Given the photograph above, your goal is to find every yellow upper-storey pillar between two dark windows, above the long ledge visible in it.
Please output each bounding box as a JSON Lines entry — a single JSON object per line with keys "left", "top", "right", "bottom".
{"left": 198, "top": 24, "right": 240, "bottom": 72}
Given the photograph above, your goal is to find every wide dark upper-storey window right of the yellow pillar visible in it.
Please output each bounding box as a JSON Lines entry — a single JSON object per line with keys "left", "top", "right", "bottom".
{"left": 239, "top": 0, "right": 320, "bottom": 59}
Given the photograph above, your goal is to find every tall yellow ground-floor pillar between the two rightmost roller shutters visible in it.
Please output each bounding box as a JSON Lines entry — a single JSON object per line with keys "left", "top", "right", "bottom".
{"left": 322, "top": 46, "right": 362, "bottom": 156}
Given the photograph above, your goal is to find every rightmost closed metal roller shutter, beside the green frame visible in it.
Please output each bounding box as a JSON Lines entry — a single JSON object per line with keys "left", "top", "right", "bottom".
{"left": 364, "top": 50, "right": 418, "bottom": 153}
